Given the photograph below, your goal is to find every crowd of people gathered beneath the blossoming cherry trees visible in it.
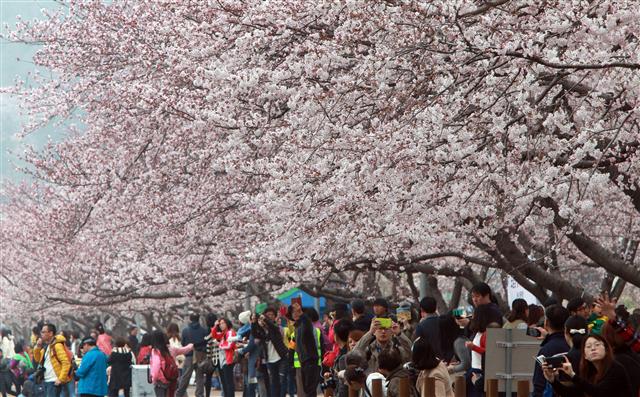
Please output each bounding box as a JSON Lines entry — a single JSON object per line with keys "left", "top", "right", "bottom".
{"left": 0, "top": 283, "right": 640, "bottom": 397}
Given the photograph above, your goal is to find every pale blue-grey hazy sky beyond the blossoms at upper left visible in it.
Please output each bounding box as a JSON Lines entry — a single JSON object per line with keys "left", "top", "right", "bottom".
{"left": 0, "top": 0, "right": 61, "bottom": 182}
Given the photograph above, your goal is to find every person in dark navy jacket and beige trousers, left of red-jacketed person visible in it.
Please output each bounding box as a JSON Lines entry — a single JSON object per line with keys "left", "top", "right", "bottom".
{"left": 176, "top": 313, "right": 210, "bottom": 397}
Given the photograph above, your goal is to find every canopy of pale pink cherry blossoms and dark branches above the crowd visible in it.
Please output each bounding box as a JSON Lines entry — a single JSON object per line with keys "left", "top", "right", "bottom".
{"left": 2, "top": 0, "right": 640, "bottom": 318}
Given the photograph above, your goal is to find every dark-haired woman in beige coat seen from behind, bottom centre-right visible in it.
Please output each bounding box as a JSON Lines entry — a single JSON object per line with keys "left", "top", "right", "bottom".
{"left": 411, "top": 338, "right": 453, "bottom": 397}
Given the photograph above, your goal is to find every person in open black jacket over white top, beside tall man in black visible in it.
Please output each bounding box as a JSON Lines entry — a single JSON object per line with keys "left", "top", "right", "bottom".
{"left": 258, "top": 307, "right": 288, "bottom": 397}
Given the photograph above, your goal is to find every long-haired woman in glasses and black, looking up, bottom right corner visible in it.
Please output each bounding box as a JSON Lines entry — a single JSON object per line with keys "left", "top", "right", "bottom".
{"left": 542, "top": 335, "right": 637, "bottom": 397}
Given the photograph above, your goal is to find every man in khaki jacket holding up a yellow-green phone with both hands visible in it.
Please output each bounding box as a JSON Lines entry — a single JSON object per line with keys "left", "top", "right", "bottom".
{"left": 354, "top": 318, "right": 411, "bottom": 371}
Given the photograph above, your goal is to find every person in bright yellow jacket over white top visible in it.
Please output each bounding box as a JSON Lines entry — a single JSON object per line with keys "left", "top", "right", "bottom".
{"left": 33, "top": 324, "right": 71, "bottom": 397}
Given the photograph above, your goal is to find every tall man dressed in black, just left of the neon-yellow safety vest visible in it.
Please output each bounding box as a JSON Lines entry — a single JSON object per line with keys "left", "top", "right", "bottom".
{"left": 291, "top": 302, "right": 320, "bottom": 397}
